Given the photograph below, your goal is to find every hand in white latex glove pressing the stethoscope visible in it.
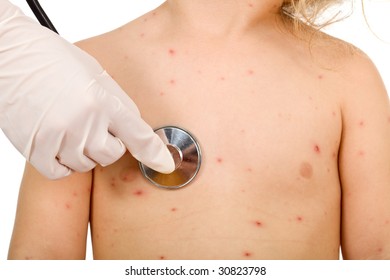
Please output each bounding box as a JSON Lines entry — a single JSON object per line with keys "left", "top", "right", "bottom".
{"left": 0, "top": 0, "right": 174, "bottom": 179}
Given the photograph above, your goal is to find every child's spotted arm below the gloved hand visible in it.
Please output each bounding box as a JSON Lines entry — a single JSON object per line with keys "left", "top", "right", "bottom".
{"left": 8, "top": 164, "right": 92, "bottom": 259}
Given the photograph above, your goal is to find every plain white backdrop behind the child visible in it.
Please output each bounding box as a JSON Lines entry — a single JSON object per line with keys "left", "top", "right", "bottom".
{"left": 0, "top": 0, "right": 390, "bottom": 261}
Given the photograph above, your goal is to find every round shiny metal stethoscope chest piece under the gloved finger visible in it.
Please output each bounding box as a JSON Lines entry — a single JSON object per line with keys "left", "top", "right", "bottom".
{"left": 139, "top": 126, "right": 202, "bottom": 189}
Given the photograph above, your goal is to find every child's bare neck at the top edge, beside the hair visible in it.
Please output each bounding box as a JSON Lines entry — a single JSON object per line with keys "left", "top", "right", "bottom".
{"left": 164, "top": 0, "right": 283, "bottom": 36}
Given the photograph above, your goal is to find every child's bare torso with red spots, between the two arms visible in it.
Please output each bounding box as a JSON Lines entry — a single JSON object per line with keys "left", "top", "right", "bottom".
{"left": 84, "top": 12, "right": 342, "bottom": 259}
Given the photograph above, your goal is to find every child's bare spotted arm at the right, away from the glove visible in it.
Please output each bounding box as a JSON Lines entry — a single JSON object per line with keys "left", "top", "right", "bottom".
{"left": 339, "top": 51, "right": 390, "bottom": 259}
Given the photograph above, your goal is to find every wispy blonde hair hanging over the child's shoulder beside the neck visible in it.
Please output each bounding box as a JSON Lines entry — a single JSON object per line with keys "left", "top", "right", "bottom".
{"left": 282, "top": 0, "right": 344, "bottom": 29}
